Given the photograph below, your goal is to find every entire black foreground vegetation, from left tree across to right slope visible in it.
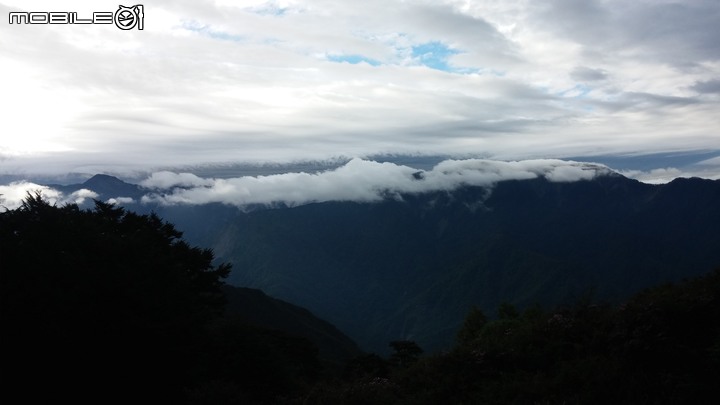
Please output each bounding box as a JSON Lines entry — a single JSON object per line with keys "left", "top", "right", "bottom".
{"left": 0, "top": 195, "right": 720, "bottom": 404}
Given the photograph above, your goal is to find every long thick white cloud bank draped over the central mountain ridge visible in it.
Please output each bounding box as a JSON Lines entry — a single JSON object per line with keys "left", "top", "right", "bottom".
{"left": 141, "top": 158, "right": 611, "bottom": 207}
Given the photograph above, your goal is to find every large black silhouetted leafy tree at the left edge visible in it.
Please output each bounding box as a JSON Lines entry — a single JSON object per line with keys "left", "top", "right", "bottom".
{"left": 0, "top": 193, "right": 230, "bottom": 402}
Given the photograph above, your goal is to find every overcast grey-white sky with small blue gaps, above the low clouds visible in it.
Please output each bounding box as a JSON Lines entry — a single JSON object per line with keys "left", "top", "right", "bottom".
{"left": 0, "top": 0, "right": 720, "bottom": 180}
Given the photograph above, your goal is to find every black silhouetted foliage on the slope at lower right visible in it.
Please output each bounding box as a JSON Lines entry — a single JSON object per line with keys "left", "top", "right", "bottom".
{"left": 296, "top": 269, "right": 720, "bottom": 404}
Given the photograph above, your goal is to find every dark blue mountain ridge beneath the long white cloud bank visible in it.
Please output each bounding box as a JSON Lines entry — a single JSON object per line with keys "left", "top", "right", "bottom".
{"left": 38, "top": 169, "right": 720, "bottom": 352}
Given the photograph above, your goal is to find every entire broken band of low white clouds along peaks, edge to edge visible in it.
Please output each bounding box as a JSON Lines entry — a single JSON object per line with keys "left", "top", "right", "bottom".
{"left": 5, "top": 157, "right": 720, "bottom": 209}
